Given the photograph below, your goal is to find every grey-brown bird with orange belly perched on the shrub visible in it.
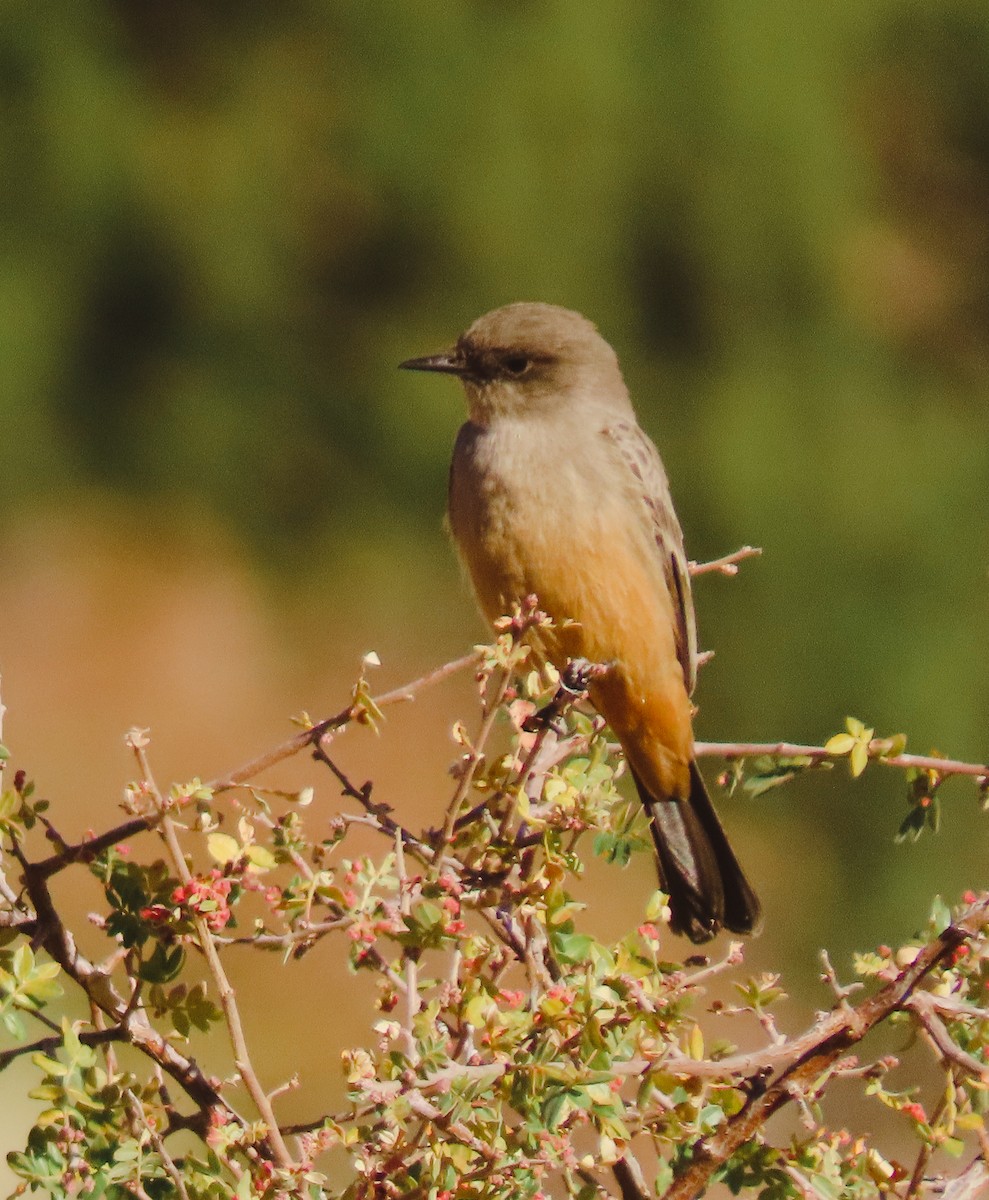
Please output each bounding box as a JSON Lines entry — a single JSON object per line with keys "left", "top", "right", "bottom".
{"left": 401, "top": 302, "right": 761, "bottom": 943}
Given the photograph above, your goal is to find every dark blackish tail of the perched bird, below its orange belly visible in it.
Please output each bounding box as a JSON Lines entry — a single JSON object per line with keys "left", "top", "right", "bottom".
{"left": 633, "top": 762, "right": 762, "bottom": 942}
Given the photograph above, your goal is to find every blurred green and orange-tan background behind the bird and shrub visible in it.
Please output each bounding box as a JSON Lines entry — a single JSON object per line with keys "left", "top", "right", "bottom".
{"left": 0, "top": 0, "right": 989, "bottom": 1180}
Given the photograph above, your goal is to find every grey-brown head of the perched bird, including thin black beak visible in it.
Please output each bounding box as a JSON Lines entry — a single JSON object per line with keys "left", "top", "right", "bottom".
{"left": 401, "top": 302, "right": 628, "bottom": 424}
